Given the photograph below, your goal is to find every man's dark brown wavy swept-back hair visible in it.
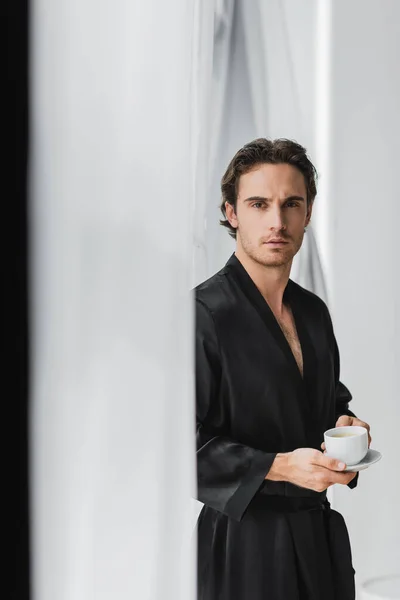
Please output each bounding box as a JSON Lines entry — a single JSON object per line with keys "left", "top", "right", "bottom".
{"left": 220, "top": 138, "right": 317, "bottom": 239}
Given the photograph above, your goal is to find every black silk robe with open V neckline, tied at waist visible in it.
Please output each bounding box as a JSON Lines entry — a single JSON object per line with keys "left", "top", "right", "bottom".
{"left": 195, "top": 255, "right": 357, "bottom": 600}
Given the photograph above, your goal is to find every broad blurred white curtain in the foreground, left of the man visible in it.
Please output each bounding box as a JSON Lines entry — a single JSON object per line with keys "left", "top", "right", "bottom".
{"left": 30, "top": 0, "right": 203, "bottom": 600}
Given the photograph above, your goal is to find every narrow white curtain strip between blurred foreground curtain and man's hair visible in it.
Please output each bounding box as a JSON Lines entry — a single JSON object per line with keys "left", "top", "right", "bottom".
{"left": 193, "top": 0, "right": 234, "bottom": 285}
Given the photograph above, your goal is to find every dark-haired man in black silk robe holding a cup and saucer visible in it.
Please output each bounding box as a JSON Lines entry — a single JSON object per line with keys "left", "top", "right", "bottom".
{"left": 195, "top": 139, "right": 369, "bottom": 600}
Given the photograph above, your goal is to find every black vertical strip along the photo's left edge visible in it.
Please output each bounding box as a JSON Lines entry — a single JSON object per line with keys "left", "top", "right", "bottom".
{"left": 7, "top": 0, "right": 30, "bottom": 600}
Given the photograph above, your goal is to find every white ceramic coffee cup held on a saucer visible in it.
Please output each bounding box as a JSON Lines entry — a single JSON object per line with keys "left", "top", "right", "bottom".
{"left": 324, "top": 425, "right": 368, "bottom": 465}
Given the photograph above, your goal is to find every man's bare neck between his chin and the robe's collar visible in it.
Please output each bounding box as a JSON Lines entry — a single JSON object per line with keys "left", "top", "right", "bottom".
{"left": 235, "top": 248, "right": 293, "bottom": 317}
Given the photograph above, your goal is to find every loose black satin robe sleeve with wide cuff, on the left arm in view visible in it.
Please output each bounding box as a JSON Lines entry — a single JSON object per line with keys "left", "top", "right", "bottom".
{"left": 196, "top": 299, "right": 276, "bottom": 521}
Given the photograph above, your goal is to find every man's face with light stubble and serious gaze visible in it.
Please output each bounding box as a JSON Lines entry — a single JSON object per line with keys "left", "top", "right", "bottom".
{"left": 225, "top": 164, "right": 312, "bottom": 267}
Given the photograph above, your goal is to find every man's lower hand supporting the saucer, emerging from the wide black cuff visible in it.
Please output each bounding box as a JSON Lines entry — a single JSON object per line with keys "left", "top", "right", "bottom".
{"left": 266, "top": 448, "right": 356, "bottom": 492}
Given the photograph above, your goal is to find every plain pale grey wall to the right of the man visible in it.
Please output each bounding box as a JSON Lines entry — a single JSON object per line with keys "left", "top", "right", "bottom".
{"left": 331, "top": 0, "right": 400, "bottom": 581}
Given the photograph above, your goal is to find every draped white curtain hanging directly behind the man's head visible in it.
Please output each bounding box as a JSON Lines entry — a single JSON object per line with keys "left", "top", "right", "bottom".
{"left": 197, "top": 0, "right": 328, "bottom": 300}
